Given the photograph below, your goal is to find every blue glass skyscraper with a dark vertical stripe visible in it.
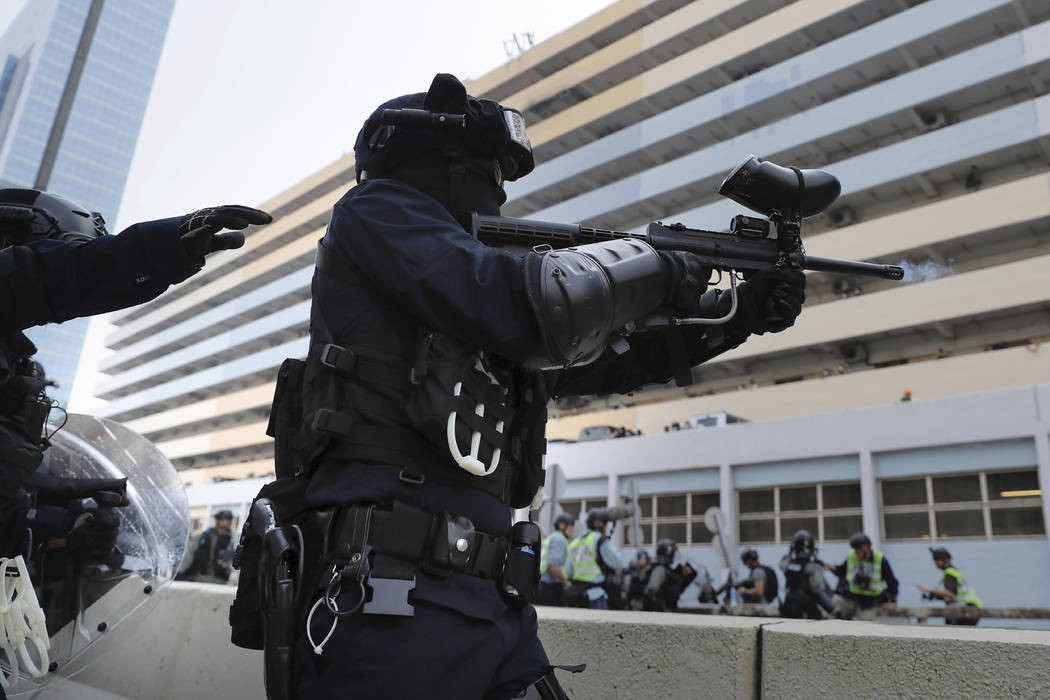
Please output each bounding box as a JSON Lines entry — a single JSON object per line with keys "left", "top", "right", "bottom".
{"left": 0, "top": 0, "right": 174, "bottom": 406}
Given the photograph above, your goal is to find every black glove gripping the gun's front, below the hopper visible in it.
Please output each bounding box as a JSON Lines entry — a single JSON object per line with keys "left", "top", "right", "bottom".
{"left": 734, "top": 270, "right": 805, "bottom": 335}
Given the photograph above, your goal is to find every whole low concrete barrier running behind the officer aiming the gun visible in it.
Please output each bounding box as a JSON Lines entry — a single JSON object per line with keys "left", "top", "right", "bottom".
{"left": 65, "top": 584, "right": 1050, "bottom": 700}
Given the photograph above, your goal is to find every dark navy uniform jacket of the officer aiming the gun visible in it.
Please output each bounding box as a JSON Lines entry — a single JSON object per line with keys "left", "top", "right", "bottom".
{"left": 308, "top": 179, "right": 726, "bottom": 619}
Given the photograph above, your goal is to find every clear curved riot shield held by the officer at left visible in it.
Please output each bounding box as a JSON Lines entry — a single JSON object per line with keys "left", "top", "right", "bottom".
{"left": 0, "top": 413, "right": 189, "bottom": 698}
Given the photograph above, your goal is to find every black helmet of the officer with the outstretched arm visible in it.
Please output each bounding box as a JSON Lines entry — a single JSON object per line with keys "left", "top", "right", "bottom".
{"left": 0, "top": 188, "right": 108, "bottom": 249}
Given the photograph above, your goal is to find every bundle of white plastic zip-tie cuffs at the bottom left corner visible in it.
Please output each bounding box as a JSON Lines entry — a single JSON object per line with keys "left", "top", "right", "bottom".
{"left": 0, "top": 555, "right": 51, "bottom": 688}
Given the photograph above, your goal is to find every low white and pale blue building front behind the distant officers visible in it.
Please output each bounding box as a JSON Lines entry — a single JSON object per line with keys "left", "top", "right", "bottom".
{"left": 187, "top": 384, "right": 1050, "bottom": 607}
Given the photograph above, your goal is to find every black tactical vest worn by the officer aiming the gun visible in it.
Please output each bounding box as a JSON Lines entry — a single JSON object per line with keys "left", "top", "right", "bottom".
{"left": 271, "top": 245, "right": 548, "bottom": 508}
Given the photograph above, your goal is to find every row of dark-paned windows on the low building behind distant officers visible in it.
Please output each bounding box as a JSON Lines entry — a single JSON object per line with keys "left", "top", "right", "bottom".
{"left": 562, "top": 469, "right": 1046, "bottom": 547}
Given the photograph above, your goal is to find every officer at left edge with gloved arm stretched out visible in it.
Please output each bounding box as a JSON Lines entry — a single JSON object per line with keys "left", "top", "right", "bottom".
{"left": 0, "top": 189, "right": 271, "bottom": 561}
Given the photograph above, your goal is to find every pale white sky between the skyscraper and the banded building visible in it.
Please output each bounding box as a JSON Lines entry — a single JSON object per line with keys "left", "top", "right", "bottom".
{"left": 0, "top": 0, "right": 612, "bottom": 411}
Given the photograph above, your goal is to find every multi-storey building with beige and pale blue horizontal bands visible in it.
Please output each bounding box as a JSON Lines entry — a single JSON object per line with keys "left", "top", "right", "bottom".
{"left": 94, "top": 0, "right": 1050, "bottom": 580}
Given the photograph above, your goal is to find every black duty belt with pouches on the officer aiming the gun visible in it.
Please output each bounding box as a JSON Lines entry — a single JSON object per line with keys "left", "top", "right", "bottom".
{"left": 319, "top": 501, "right": 508, "bottom": 615}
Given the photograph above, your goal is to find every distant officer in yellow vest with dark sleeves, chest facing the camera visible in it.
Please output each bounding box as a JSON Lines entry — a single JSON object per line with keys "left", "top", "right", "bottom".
{"left": 824, "top": 532, "right": 900, "bottom": 620}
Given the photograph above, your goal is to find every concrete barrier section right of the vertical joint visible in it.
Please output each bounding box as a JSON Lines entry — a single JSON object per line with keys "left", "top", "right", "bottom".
{"left": 761, "top": 620, "right": 1050, "bottom": 700}
